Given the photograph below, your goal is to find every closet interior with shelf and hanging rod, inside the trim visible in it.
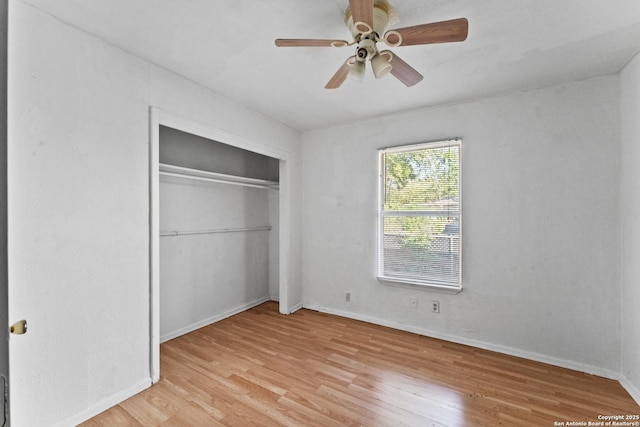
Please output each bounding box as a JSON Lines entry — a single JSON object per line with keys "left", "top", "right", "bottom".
{"left": 159, "top": 126, "right": 279, "bottom": 342}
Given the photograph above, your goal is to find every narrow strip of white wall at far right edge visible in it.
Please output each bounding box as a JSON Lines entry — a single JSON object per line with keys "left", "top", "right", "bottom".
{"left": 620, "top": 51, "right": 640, "bottom": 402}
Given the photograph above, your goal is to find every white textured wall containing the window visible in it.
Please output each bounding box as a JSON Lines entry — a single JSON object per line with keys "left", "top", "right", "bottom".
{"left": 302, "top": 77, "right": 621, "bottom": 377}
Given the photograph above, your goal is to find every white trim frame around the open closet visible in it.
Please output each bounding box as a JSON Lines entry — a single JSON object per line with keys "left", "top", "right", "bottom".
{"left": 149, "top": 106, "right": 292, "bottom": 384}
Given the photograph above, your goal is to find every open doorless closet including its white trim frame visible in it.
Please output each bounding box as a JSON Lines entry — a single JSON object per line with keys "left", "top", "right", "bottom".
{"left": 150, "top": 108, "right": 292, "bottom": 383}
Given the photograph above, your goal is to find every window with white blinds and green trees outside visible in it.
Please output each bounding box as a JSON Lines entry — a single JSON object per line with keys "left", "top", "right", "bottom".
{"left": 378, "top": 140, "right": 462, "bottom": 290}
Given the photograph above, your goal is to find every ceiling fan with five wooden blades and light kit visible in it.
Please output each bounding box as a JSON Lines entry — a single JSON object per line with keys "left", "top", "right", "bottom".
{"left": 276, "top": 0, "right": 469, "bottom": 89}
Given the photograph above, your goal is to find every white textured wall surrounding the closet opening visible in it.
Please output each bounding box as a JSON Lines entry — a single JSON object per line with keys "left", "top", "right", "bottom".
{"left": 9, "top": 0, "right": 300, "bottom": 427}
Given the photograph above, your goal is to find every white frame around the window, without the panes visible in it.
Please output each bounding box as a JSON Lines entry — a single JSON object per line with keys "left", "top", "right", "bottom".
{"left": 376, "top": 138, "right": 463, "bottom": 294}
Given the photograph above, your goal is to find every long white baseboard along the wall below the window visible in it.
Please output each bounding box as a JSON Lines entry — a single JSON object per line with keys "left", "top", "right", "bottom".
{"left": 318, "top": 305, "right": 624, "bottom": 382}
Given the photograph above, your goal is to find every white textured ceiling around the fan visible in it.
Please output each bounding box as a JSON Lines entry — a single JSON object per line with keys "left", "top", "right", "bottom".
{"left": 19, "top": 0, "right": 640, "bottom": 131}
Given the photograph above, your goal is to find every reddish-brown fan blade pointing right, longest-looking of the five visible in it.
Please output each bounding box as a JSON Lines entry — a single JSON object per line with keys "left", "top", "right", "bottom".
{"left": 384, "top": 18, "right": 469, "bottom": 47}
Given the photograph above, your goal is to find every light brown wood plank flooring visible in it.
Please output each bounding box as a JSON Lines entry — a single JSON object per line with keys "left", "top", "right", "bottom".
{"left": 83, "top": 302, "right": 640, "bottom": 427}
